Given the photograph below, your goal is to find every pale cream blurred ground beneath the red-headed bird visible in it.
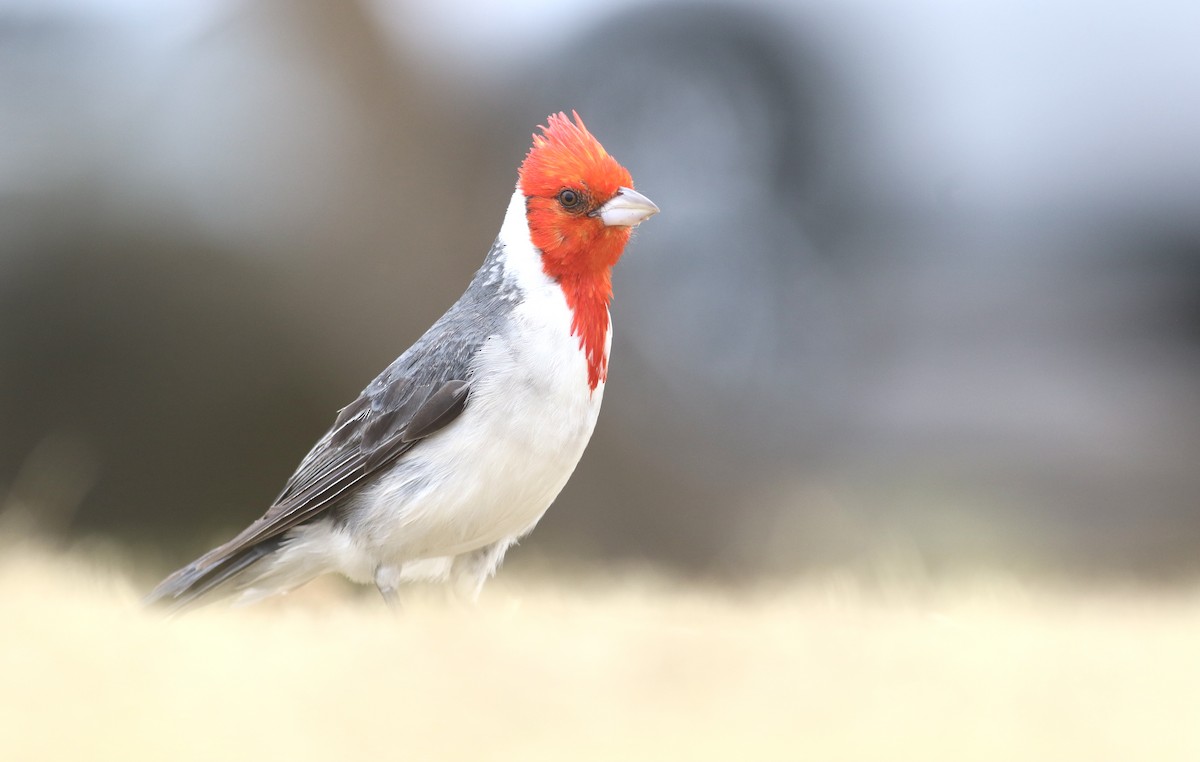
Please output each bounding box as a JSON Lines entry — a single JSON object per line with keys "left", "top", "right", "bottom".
{"left": 0, "top": 545, "right": 1200, "bottom": 762}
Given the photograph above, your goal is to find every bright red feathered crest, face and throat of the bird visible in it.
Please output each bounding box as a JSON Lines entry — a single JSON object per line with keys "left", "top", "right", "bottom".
{"left": 520, "top": 113, "right": 634, "bottom": 391}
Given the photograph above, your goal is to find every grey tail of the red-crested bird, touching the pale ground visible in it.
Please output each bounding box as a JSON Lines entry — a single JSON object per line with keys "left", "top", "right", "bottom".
{"left": 143, "top": 536, "right": 283, "bottom": 613}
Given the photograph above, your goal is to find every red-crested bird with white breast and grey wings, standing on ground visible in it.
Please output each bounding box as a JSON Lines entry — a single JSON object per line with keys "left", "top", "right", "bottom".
{"left": 145, "top": 110, "right": 659, "bottom": 611}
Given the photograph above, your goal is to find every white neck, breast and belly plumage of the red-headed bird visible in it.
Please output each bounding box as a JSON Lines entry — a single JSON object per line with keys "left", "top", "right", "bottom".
{"left": 338, "top": 193, "right": 612, "bottom": 578}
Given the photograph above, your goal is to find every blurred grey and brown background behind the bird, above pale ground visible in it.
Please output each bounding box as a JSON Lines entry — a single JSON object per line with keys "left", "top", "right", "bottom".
{"left": 0, "top": 0, "right": 1200, "bottom": 580}
